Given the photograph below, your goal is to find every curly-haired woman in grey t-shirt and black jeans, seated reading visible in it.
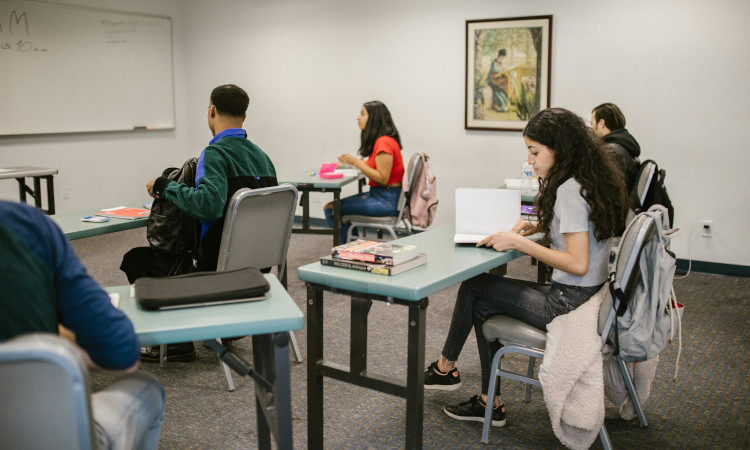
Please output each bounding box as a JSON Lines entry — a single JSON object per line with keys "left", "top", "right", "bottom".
{"left": 424, "top": 108, "right": 628, "bottom": 427}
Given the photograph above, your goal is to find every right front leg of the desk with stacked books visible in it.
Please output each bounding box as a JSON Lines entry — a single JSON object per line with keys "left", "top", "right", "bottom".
{"left": 406, "top": 299, "right": 427, "bottom": 448}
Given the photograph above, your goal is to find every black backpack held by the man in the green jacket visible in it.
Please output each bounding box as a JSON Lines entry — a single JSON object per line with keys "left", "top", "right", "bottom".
{"left": 146, "top": 158, "right": 200, "bottom": 275}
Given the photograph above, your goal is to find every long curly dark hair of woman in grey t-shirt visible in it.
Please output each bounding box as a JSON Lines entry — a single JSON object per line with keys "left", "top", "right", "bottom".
{"left": 523, "top": 108, "right": 628, "bottom": 241}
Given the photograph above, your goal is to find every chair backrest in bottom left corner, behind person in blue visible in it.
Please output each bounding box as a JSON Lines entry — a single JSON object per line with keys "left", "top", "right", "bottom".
{"left": 0, "top": 333, "right": 94, "bottom": 449}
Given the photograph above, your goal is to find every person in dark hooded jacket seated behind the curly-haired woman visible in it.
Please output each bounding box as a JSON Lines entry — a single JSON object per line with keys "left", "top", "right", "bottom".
{"left": 591, "top": 103, "right": 641, "bottom": 192}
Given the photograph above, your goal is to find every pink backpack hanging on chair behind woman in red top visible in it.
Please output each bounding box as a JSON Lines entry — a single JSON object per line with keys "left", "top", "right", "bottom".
{"left": 403, "top": 152, "right": 438, "bottom": 228}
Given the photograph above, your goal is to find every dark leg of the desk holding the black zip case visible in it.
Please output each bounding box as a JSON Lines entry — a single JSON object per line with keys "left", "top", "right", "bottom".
{"left": 253, "top": 333, "right": 293, "bottom": 449}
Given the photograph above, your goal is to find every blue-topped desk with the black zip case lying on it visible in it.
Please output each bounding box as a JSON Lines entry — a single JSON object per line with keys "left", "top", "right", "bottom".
{"left": 107, "top": 275, "right": 304, "bottom": 449}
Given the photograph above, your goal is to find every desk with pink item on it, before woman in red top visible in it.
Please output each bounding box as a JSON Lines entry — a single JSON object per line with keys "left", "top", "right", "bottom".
{"left": 279, "top": 169, "right": 365, "bottom": 247}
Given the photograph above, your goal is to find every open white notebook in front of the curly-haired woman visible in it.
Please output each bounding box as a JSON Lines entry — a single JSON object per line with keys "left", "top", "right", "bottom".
{"left": 453, "top": 188, "right": 521, "bottom": 244}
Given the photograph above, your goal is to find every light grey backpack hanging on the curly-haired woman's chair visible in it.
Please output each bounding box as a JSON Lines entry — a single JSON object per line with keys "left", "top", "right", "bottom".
{"left": 609, "top": 205, "right": 682, "bottom": 364}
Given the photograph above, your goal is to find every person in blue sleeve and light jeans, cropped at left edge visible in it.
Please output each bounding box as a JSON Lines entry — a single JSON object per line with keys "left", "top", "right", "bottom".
{"left": 0, "top": 200, "right": 164, "bottom": 449}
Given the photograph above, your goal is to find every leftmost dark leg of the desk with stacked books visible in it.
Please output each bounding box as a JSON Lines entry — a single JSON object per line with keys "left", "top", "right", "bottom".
{"left": 307, "top": 284, "right": 323, "bottom": 449}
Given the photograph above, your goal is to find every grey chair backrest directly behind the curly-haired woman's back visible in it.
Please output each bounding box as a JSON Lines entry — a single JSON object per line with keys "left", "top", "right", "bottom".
{"left": 599, "top": 215, "right": 656, "bottom": 344}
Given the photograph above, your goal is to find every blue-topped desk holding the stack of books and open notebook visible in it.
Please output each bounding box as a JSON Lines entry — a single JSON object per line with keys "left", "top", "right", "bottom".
{"left": 297, "top": 225, "right": 523, "bottom": 449}
